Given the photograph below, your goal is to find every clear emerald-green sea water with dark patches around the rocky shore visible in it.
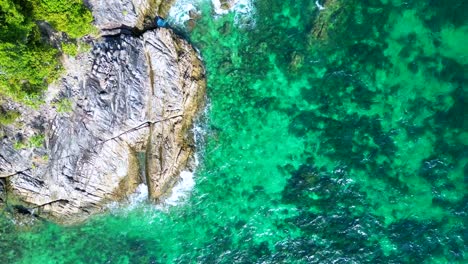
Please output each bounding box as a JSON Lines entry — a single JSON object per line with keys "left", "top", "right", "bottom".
{"left": 0, "top": 0, "right": 468, "bottom": 263}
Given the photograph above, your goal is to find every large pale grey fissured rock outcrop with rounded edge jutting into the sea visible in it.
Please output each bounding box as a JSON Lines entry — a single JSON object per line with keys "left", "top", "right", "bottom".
{"left": 0, "top": 1, "right": 205, "bottom": 223}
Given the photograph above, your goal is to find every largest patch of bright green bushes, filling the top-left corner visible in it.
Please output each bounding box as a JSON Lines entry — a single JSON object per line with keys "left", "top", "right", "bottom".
{"left": 0, "top": 0, "right": 92, "bottom": 105}
